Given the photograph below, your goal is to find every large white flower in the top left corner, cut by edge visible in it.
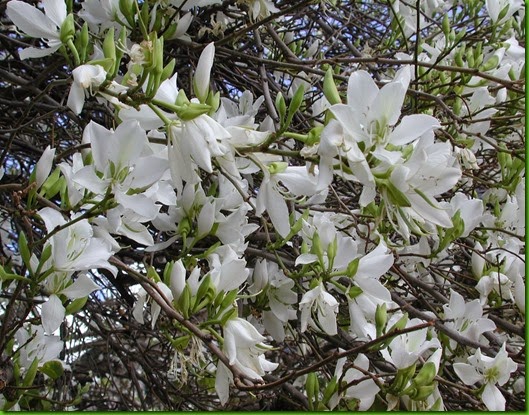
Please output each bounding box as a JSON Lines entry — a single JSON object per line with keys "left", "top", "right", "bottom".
{"left": 6, "top": 0, "right": 67, "bottom": 59}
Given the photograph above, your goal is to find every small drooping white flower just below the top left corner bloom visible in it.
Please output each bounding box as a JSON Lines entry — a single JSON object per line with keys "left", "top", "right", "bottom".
{"left": 66, "top": 65, "right": 107, "bottom": 114}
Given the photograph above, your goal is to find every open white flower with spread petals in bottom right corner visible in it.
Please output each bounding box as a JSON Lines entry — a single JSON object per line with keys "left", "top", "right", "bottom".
{"left": 454, "top": 343, "right": 518, "bottom": 411}
